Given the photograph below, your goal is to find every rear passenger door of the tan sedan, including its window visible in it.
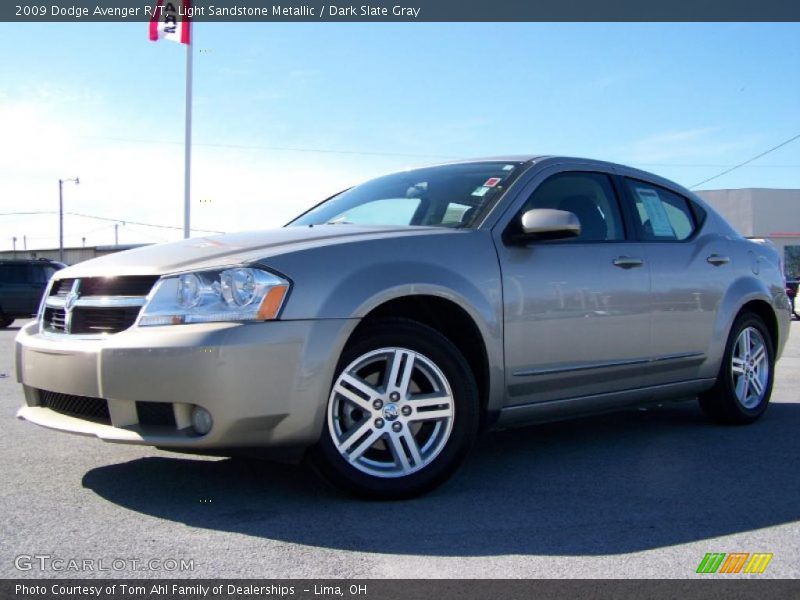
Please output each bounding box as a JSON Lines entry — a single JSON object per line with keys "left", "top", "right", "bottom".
{"left": 623, "top": 177, "right": 732, "bottom": 385}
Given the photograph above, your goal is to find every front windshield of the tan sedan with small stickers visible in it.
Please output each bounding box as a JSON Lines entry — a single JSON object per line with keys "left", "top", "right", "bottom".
{"left": 289, "top": 161, "right": 519, "bottom": 227}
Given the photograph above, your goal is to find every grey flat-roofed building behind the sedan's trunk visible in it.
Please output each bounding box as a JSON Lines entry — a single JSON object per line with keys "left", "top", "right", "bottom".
{"left": 697, "top": 188, "right": 800, "bottom": 278}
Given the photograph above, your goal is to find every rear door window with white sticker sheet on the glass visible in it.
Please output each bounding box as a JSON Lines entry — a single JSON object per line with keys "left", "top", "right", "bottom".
{"left": 625, "top": 179, "right": 695, "bottom": 242}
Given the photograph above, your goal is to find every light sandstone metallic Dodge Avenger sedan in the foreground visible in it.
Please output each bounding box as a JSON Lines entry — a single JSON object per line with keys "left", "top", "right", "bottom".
{"left": 16, "top": 157, "right": 789, "bottom": 498}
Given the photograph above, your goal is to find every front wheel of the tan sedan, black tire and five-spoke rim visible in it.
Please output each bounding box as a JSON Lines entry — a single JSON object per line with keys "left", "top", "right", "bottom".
{"left": 310, "top": 319, "right": 479, "bottom": 500}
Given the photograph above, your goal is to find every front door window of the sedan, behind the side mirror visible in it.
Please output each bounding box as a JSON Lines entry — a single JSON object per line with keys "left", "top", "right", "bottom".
{"left": 520, "top": 172, "right": 625, "bottom": 242}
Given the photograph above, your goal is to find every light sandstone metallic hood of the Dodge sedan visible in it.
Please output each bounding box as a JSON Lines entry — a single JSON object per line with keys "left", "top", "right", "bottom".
{"left": 56, "top": 225, "right": 458, "bottom": 279}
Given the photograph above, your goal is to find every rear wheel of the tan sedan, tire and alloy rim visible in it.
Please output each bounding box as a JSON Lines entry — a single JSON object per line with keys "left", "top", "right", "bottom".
{"left": 700, "top": 312, "right": 775, "bottom": 425}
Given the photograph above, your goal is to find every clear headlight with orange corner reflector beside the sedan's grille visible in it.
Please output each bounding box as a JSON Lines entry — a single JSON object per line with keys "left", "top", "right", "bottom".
{"left": 139, "top": 267, "right": 289, "bottom": 327}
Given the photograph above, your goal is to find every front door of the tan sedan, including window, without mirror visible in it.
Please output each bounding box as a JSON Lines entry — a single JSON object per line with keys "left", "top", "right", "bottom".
{"left": 498, "top": 170, "right": 650, "bottom": 405}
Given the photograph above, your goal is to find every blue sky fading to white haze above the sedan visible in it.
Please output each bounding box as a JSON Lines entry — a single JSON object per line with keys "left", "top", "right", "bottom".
{"left": 0, "top": 23, "right": 800, "bottom": 249}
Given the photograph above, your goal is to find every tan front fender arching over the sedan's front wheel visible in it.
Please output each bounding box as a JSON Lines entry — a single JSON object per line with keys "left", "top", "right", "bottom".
{"left": 265, "top": 230, "right": 503, "bottom": 418}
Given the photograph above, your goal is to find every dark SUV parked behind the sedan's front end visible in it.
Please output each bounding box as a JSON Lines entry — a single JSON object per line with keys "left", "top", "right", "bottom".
{"left": 0, "top": 258, "right": 66, "bottom": 328}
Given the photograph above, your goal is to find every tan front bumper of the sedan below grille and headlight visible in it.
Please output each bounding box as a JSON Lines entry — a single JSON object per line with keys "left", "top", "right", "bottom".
{"left": 15, "top": 319, "right": 358, "bottom": 452}
